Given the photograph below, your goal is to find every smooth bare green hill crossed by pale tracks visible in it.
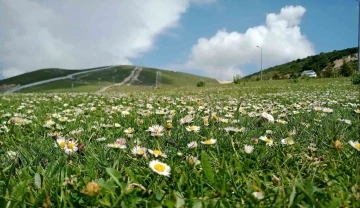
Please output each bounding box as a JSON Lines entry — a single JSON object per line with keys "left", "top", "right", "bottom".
{"left": 0, "top": 65, "right": 218, "bottom": 92}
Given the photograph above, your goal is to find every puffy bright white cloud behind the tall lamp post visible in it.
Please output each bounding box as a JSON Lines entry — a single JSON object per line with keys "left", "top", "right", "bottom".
{"left": 185, "top": 6, "right": 315, "bottom": 79}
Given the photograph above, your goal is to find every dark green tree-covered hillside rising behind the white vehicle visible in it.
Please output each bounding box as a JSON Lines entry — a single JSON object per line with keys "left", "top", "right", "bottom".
{"left": 244, "top": 47, "right": 358, "bottom": 79}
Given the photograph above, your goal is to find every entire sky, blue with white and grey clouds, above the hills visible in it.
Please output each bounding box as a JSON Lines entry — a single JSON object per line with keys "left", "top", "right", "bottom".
{"left": 0, "top": 0, "right": 358, "bottom": 79}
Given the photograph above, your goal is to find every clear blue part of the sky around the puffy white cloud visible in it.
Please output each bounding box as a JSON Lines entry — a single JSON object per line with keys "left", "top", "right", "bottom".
{"left": 133, "top": 0, "right": 358, "bottom": 75}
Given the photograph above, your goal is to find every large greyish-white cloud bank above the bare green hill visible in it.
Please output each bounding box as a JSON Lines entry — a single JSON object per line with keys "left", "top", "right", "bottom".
{"left": 0, "top": 0, "right": 213, "bottom": 77}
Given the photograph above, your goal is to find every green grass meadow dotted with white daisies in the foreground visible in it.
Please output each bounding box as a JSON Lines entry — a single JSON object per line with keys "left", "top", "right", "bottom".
{"left": 0, "top": 79, "right": 360, "bottom": 208}
